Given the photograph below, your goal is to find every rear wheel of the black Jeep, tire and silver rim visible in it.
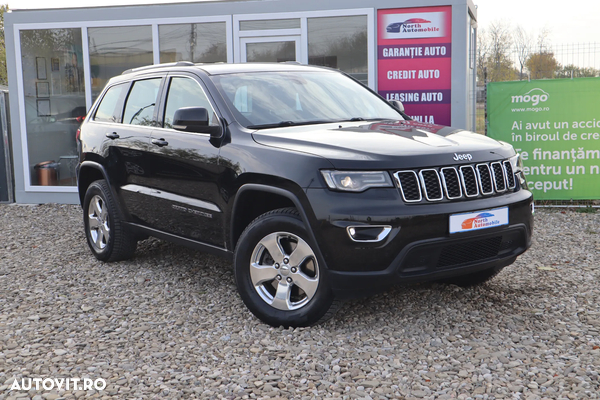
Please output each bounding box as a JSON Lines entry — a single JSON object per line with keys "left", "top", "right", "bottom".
{"left": 83, "top": 179, "right": 137, "bottom": 262}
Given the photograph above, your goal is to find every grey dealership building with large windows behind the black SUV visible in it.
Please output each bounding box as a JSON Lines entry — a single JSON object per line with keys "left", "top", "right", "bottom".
{"left": 0, "top": 0, "right": 477, "bottom": 203}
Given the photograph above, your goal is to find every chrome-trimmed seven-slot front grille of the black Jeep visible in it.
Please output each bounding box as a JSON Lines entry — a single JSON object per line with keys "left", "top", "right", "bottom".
{"left": 394, "top": 160, "right": 516, "bottom": 203}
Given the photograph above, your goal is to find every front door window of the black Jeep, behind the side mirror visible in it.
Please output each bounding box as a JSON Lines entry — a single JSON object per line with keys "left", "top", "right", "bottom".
{"left": 164, "top": 77, "right": 218, "bottom": 128}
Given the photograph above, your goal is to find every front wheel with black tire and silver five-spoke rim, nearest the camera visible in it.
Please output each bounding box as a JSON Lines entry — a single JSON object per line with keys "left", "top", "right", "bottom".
{"left": 234, "top": 208, "right": 339, "bottom": 328}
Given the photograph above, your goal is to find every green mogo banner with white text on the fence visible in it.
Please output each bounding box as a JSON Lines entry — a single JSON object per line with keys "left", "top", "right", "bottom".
{"left": 487, "top": 78, "right": 600, "bottom": 200}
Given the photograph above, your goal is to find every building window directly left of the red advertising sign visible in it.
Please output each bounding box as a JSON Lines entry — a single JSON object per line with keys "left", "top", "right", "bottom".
{"left": 308, "top": 15, "right": 368, "bottom": 85}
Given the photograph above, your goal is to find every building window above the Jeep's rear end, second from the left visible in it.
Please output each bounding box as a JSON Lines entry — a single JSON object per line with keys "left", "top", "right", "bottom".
{"left": 88, "top": 25, "right": 153, "bottom": 100}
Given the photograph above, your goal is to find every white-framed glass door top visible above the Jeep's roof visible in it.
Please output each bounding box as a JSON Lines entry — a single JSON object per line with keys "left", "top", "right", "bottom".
{"left": 240, "top": 36, "right": 301, "bottom": 62}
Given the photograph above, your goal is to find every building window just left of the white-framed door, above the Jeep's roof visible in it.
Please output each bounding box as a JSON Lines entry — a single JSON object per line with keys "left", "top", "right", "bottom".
{"left": 158, "top": 22, "right": 227, "bottom": 63}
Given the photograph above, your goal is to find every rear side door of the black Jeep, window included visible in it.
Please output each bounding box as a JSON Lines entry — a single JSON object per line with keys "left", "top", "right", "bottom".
{"left": 111, "top": 74, "right": 164, "bottom": 226}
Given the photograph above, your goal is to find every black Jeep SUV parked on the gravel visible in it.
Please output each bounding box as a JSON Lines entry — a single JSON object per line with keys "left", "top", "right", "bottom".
{"left": 78, "top": 62, "right": 533, "bottom": 326}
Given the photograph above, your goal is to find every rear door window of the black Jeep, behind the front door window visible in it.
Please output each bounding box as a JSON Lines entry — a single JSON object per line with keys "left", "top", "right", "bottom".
{"left": 123, "top": 78, "right": 162, "bottom": 126}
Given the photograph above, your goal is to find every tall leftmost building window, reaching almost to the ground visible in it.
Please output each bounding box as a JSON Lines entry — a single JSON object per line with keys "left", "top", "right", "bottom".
{"left": 20, "top": 29, "right": 86, "bottom": 186}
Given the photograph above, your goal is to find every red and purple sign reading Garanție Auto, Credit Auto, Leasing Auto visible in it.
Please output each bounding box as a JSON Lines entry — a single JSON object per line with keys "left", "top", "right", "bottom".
{"left": 377, "top": 6, "right": 452, "bottom": 125}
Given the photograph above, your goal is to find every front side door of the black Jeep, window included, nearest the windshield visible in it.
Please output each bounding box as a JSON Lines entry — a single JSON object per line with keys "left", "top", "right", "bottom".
{"left": 149, "top": 73, "right": 224, "bottom": 247}
